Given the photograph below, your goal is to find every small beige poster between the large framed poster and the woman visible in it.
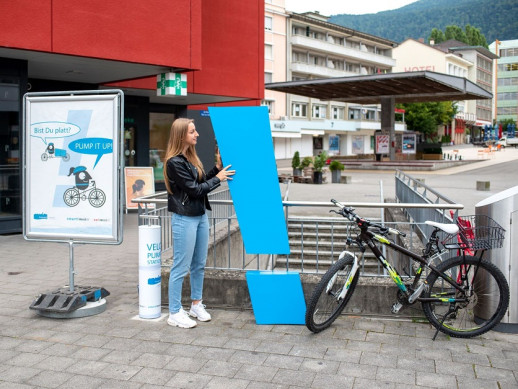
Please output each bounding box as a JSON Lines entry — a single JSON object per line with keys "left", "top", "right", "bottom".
{"left": 124, "top": 167, "right": 155, "bottom": 209}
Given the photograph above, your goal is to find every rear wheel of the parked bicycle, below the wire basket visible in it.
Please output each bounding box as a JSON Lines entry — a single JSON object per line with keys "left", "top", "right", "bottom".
{"left": 421, "top": 255, "right": 509, "bottom": 338}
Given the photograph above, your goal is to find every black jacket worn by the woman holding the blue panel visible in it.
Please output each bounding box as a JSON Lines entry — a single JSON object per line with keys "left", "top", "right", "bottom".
{"left": 166, "top": 154, "right": 220, "bottom": 216}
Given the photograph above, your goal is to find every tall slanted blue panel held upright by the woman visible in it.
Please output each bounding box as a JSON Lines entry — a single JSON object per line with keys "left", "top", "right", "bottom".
{"left": 209, "top": 107, "right": 290, "bottom": 254}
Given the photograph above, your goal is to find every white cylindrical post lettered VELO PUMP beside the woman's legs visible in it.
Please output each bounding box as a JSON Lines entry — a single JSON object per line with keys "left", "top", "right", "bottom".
{"left": 138, "top": 225, "right": 162, "bottom": 319}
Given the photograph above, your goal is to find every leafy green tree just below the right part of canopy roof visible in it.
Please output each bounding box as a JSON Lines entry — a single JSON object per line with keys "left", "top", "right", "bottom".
{"left": 397, "top": 101, "right": 457, "bottom": 143}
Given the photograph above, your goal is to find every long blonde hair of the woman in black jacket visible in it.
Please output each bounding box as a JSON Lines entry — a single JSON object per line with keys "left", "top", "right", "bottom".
{"left": 164, "top": 118, "right": 204, "bottom": 193}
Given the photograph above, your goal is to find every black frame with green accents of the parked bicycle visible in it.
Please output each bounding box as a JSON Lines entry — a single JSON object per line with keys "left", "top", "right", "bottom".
{"left": 359, "top": 226, "right": 466, "bottom": 303}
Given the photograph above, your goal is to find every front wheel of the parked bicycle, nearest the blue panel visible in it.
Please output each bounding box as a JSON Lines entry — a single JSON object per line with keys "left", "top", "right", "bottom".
{"left": 306, "top": 254, "right": 360, "bottom": 333}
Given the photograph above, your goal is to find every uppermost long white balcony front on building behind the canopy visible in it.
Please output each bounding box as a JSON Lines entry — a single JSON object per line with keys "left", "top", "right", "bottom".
{"left": 291, "top": 35, "right": 396, "bottom": 67}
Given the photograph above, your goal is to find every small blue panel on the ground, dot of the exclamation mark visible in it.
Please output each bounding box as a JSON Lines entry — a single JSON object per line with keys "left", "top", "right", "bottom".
{"left": 246, "top": 270, "right": 306, "bottom": 324}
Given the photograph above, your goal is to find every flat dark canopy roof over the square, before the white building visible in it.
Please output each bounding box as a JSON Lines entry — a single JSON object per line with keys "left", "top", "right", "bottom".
{"left": 265, "top": 71, "right": 493, "bottom": 104}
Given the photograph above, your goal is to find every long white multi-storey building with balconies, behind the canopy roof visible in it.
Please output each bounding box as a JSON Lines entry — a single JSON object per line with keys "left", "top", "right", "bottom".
{"left": 263, "top": 0, "right": 405, "bottom": 159}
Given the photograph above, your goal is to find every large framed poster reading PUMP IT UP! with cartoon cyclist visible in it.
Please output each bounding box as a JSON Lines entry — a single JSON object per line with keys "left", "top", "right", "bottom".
{"left": 23, "top": 91, "right": 123, "bottom": 243}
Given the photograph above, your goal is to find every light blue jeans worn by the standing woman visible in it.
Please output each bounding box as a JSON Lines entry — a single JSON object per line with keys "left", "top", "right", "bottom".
{"left": 169, "top": 213, "right": 209, "bottom": 313}
